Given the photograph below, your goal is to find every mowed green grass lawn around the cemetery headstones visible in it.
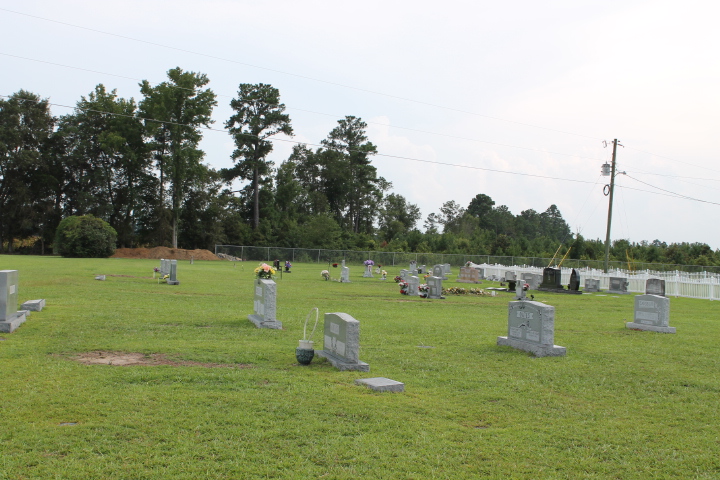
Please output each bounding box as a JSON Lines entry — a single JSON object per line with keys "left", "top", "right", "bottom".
{"left": 0, "top": 256, "right": 720, "bottom": 479}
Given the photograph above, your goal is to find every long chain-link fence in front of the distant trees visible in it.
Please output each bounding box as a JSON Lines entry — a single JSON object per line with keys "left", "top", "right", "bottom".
{"left": 215, "top": 245, "right": 720, "bottom": 273}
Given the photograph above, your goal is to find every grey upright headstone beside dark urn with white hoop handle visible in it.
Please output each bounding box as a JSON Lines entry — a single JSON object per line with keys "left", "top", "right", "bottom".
{"left": 315, "top": 313, "right": 370, "bottom": 372}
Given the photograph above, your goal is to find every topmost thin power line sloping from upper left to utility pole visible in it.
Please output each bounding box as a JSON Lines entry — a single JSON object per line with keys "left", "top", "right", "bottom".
{"left": 0, "top": 8, "right": 602, "bottom": 140}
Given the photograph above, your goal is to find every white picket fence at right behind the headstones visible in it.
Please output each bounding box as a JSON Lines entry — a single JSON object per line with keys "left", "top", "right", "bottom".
{"left": 481, "top": 264, "right": 720, "bottom": 300}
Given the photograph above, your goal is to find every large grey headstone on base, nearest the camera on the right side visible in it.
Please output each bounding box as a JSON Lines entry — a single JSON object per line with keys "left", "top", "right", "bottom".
{"left": 497, "top": 300, "right": 566, "bottom": 357}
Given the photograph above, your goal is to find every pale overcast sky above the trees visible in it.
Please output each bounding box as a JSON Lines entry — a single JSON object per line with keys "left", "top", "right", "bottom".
{"left": 0, "top": 0, "right": 720, "bottom": 249}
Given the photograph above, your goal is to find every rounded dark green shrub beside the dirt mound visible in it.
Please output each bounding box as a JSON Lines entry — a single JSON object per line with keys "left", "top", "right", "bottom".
{"left": 55, "top": 215, "right": 117, "bottom": 258}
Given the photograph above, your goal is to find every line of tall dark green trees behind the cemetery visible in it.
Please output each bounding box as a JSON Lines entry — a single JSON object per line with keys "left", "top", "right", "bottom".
{"left": 0, "top": 68, "right": 720, "bottom": 265}
